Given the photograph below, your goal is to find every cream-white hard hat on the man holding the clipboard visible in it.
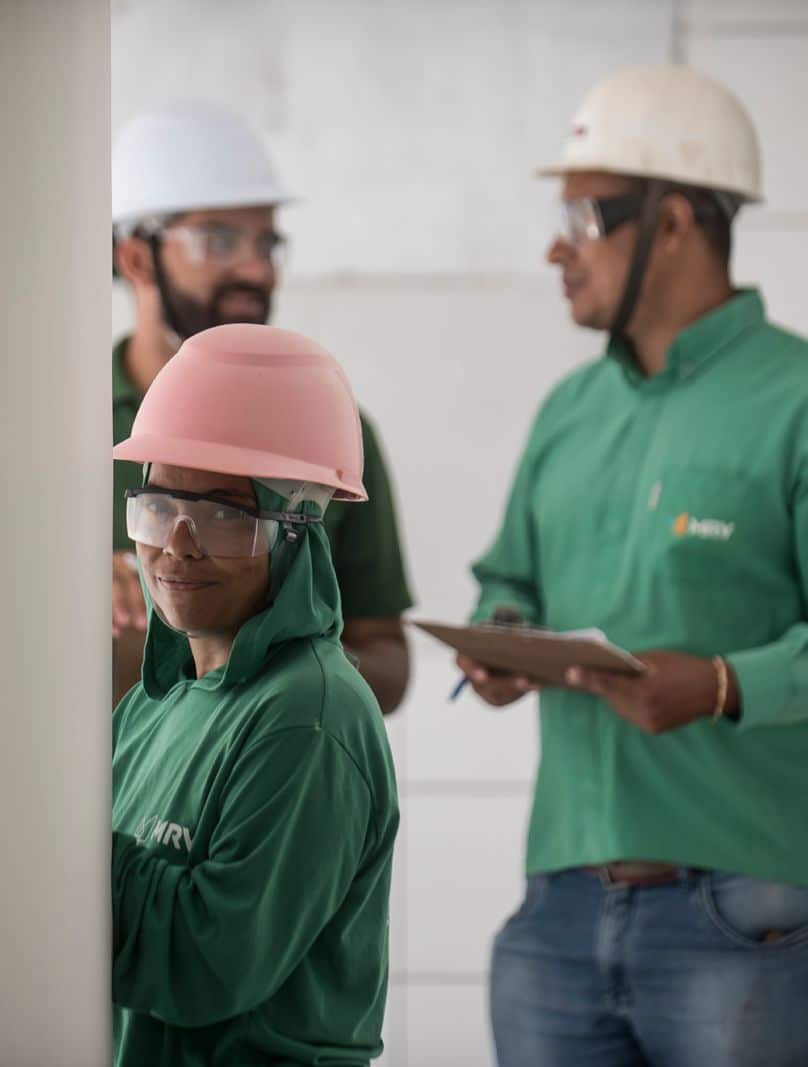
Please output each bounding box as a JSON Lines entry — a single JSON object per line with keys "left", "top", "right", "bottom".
{"left": 537, "top": 64, "right": 762, "bottom": 202}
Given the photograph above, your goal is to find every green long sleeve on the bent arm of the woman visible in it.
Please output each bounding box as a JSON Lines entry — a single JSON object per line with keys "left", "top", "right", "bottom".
{"left": 112, "top": 728, "right": 375, "bottom": 1028}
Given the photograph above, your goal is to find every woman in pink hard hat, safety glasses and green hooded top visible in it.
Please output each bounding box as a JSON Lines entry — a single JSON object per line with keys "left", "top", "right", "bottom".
{"left": 112, "top": 324, "right": 398, "bottom": 1067}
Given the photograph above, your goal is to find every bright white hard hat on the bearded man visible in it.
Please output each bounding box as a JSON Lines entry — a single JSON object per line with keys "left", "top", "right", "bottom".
{"left": 112, "top": 103, "right": 290, "bottom": 229}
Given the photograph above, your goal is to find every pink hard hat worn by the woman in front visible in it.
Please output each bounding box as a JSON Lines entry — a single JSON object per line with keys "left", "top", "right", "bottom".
{"left": 112, "top": 323, "right": 367, "bottom": 500}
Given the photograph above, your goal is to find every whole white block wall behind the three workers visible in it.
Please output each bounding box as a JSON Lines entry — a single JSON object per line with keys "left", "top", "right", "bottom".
{"left": 112, "top": 0, "right": 808, "bottom": 1067}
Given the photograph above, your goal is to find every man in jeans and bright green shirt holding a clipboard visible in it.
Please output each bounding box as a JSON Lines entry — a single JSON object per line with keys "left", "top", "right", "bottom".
{"left": 458, "top": 66, "right": 808, "bottom": 1067}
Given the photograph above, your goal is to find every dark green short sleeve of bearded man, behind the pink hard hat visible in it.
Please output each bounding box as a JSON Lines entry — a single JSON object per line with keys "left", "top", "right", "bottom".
{"left": 327, "top": 415, "right": 412, "bottom": 619}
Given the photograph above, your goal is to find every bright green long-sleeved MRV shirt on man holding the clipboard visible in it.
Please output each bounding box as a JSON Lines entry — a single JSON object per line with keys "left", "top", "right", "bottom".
{"left": 474, "top": 291, "right": 808, "bottom": 885}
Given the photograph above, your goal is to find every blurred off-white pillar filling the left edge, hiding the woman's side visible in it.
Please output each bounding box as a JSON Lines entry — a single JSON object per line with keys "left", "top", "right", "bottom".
{"left": 0, "top": 0, "right": 112, "bottom": 1067}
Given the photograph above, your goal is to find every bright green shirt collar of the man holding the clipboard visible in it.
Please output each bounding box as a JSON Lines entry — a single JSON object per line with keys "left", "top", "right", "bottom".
{"left": 606, "top": 289, "right": 765, "bottom": 385}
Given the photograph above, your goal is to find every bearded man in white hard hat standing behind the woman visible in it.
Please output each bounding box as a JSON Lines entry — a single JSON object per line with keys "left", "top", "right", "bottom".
{"left": 112, "top": 105, "right": 412, "bottom": 713}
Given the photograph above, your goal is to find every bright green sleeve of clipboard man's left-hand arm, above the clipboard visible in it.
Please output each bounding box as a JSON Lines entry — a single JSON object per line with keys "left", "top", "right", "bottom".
{"left": 472, "top": 409, "right": 543, "bottom": 626}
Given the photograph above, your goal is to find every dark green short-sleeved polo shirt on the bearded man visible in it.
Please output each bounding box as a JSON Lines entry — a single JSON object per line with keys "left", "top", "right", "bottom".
{"left": 112, "top": 338, "right": 412, "bottom": 619}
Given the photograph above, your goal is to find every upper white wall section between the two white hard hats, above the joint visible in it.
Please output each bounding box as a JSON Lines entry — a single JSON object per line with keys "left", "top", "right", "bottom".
{"left": 112, "top": 0, "right": 671, "bottom": 275}
